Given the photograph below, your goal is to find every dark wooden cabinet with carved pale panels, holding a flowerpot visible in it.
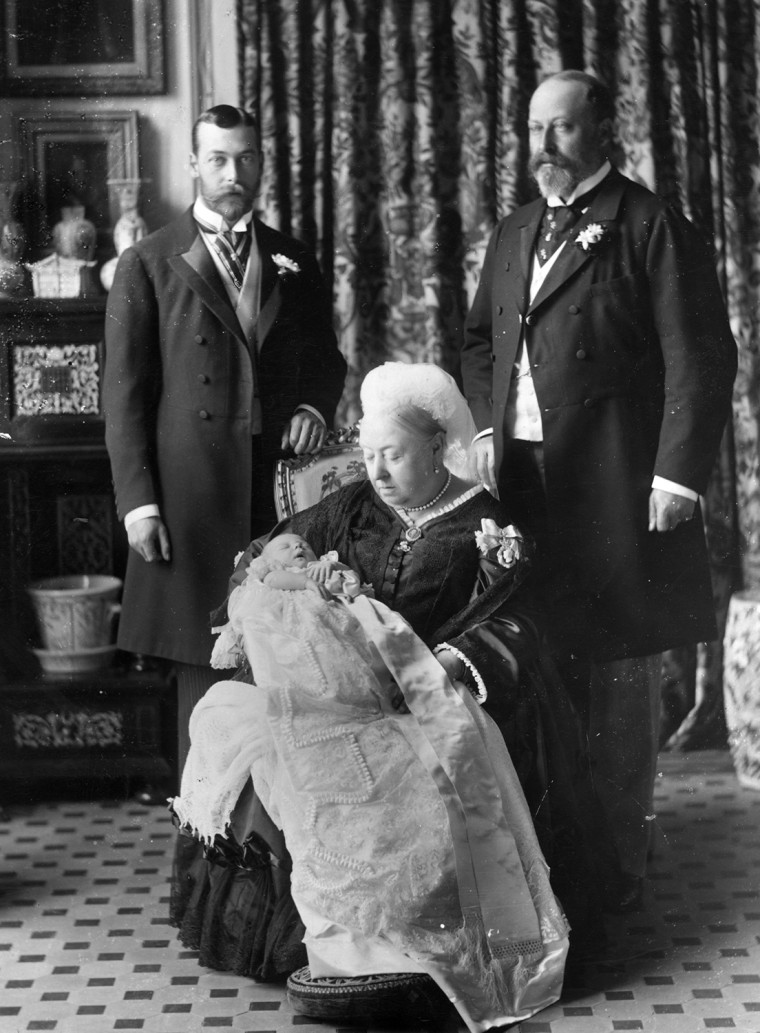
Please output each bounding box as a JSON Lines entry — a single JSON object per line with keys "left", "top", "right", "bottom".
{"left": 0, "top": 298, "right": 175, "bottom": 797}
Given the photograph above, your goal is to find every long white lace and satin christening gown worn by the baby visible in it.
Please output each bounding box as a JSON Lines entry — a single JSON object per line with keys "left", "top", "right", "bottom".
{"left": 175, "top": 545, "right": 568, "bottom": 1033}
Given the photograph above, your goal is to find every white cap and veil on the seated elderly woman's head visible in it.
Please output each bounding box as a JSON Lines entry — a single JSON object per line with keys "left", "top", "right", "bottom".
{"left": 360, "top": 363, "right": 477, "bottom": 483}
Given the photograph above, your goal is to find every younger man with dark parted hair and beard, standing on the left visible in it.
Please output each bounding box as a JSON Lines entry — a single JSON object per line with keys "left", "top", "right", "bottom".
{"left": 103, "top": 104, "right": 346, "bottom": 770}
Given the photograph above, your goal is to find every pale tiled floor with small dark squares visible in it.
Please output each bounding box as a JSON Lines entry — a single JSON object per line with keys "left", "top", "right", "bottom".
{"left": 0, "top": 752, "right": 760, "bottom": 1033}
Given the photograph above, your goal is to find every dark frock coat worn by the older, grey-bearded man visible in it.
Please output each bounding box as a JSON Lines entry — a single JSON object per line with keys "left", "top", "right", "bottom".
{"left": 462, "top": 169, "right": 736, "bottom": 660}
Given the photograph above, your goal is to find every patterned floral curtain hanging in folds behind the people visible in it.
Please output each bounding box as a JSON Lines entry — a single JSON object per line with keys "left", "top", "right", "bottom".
{"left": 239, "top": 0, "right": 760, "bottom": 749}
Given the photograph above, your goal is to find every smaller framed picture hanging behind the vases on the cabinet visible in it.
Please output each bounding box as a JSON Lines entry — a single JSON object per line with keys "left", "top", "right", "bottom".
{"left": 20, "top": 112, "right": 139, "bottom": 253}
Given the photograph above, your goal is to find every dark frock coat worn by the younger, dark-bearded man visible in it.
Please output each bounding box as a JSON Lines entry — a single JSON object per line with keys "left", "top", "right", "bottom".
{"left": 103, "top": 211, "right": 346, "bottom": 665}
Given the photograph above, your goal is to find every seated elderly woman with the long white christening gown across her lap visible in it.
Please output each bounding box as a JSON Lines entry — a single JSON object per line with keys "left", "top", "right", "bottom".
{"left": 171, "top": 363, "right": 601, "bottom": 1031}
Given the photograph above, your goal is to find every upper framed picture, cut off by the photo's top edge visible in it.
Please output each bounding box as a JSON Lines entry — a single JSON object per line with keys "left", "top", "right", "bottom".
{"left": 0, "top": 0, "right": 164, "bottom": 97}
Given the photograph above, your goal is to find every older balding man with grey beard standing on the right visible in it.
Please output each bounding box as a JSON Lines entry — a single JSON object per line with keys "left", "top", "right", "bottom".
{"left": 462, "top": 70, "right": 736, "bottom": 911}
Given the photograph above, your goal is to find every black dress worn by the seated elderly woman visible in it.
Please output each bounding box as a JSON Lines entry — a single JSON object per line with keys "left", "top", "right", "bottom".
{"left": 170, "top": 481, "right": 612, "bottom": 980}
